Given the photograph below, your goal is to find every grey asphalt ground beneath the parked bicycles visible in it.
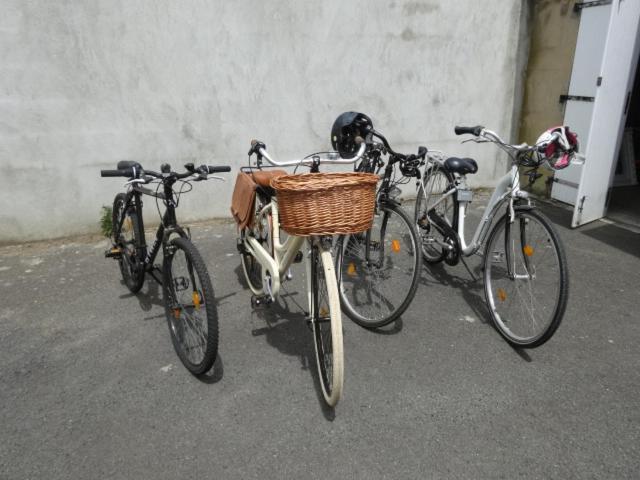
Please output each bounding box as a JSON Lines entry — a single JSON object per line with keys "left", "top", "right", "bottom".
{"left": 0, "top": 196, "right": 640, "bottom": 479}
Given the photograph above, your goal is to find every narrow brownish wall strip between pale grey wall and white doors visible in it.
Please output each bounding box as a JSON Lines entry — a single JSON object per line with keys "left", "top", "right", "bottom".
{"left": 519, "top": 0, "right": 580, "bottom": 194}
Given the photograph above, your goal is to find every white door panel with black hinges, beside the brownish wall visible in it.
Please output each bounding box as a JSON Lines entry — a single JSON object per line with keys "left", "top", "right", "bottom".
{"left": 549, "top": 0, "right": 608, "bottom": 205}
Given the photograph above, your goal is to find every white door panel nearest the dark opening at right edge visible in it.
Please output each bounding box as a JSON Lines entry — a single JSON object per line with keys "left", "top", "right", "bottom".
{"left": 569, "top": 0, "right": 640, "bottom": 227}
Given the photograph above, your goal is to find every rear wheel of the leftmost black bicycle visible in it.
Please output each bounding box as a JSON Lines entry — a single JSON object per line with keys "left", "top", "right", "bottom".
{"left": 111, "top": 193, "right": 144, "bottom": 293}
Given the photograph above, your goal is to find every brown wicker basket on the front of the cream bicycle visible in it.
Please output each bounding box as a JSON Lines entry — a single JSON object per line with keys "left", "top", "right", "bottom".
{"left": 271, "top": 173, "right": 379, "bottom": 236}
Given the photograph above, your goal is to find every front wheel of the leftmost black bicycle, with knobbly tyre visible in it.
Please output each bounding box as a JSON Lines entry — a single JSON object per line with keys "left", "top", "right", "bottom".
{"left": 163, "top": 238, "right": 218, "bottom": 375}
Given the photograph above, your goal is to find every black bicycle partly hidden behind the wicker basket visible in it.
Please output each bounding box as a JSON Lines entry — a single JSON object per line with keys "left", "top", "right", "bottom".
{"left": 334, "top": 117, "right": 427, "bottom": 329}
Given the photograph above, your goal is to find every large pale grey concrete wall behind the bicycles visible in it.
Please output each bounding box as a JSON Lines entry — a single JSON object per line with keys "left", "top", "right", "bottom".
{"left": 0, "top": 0, "right": 527, "bottom": 242}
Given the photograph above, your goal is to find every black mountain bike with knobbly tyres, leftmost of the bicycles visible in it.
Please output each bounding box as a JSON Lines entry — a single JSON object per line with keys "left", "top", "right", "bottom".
{"left": 101, "top": 161, "right": 231, "bottom": 375}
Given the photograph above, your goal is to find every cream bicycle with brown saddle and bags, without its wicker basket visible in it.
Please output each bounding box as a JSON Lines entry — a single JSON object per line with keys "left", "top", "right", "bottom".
{"left": 232, "top": 140, "right": 375, "bottom": 407}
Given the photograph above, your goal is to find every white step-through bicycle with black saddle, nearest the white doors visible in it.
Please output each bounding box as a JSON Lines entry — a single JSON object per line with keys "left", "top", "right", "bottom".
{"left": 414, "top": 126, "right": 577, "bottom": 348}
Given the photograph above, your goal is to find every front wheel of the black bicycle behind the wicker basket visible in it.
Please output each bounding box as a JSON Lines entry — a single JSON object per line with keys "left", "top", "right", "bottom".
{"left": 336, "top": 205, "right": 420, "bottom": 328}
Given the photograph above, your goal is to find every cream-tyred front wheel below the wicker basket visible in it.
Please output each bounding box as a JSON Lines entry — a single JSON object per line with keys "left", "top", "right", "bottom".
{"left": 309, "top": 245, "right": 344, "bottom": 407}
